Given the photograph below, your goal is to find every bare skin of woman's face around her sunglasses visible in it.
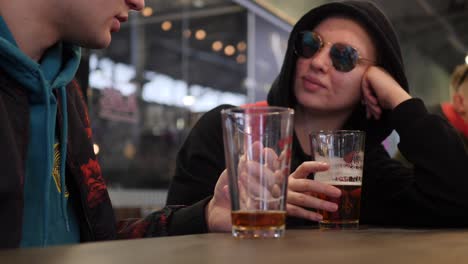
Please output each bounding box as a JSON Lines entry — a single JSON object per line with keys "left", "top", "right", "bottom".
{"left": 294, "top": 17, "right": 376, "bottom": 113}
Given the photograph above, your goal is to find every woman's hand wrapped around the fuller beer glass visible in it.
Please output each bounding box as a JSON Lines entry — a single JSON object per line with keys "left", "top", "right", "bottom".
{"left": 286, "top": 161, "right": 341, "bottom": 221}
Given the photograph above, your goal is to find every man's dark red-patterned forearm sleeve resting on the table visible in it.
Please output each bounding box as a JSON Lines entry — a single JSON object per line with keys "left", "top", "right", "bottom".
{"left": 117, "top": 197, "right": 211, "bottom": 239}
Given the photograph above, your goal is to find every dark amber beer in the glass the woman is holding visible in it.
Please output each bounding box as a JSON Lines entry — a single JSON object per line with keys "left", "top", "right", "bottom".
{"left": 318, "top": 182, "right": 361, "bottom": 229}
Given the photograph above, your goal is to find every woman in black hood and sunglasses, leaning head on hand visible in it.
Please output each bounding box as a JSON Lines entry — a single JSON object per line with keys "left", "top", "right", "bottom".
{"left": 167, "top": 1, "right": 468, "bottom": 227}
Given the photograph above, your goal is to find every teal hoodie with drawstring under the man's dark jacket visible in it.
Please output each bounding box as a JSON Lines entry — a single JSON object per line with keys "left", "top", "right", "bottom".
{"left": 0, "top": 16, "right": 81, "bottom": 247}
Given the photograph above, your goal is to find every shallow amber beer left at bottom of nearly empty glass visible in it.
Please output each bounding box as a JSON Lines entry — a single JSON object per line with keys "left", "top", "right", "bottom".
{"left": 231, "top": 211, "right": 286, "bottom": 237}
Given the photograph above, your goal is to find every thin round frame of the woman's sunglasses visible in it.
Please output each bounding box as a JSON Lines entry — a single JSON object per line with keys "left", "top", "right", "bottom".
{"left": 294, "top": 30, "right": 376, "bottom": 72}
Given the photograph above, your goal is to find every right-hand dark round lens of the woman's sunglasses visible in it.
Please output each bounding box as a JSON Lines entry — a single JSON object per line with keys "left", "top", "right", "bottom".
{"left": 330, "top": 43, "right": 359, "bottom": 72}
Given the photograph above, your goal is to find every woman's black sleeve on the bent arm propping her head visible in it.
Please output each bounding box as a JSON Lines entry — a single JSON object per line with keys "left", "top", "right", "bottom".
{"left": 361, "top": 99, "right": 468, "bottom": 227}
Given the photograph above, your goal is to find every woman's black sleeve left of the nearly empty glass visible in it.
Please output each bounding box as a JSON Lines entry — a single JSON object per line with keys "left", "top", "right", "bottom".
{"left": 166, "top": 105, "right": 232, "bottom": 205}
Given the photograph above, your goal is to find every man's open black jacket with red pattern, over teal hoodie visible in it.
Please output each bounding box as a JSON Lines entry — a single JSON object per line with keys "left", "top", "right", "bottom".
{"left": 0, "top": 69, "right": 208, "bottom": 248}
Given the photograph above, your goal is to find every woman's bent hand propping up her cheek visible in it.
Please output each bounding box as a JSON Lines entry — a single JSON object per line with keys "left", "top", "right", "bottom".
{"left": 361, "top": 66, "right": 411, "bottom": 120}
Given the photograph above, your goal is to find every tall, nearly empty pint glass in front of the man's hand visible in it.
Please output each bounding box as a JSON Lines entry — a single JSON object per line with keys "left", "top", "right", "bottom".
{"left": 221, "top": 107, "right": 294, "bottom": 238}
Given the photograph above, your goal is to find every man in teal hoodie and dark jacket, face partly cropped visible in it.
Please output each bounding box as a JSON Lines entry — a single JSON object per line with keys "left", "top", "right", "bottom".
{"left": 0, "top": 0, "right": 230, "bottom": 248}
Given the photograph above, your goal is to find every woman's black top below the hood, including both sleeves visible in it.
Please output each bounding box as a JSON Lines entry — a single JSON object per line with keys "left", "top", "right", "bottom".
{"left": 167, "top": 99, "right": 468, "bottom": 227}
